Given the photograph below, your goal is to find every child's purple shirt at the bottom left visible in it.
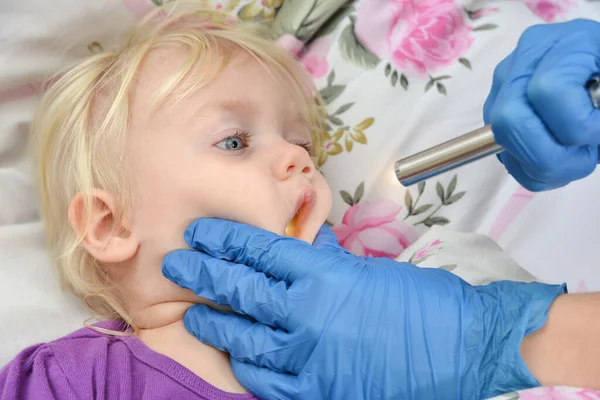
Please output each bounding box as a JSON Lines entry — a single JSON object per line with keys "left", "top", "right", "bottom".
{"left": 0, "top": 322, "right": 255, "bottom": 400}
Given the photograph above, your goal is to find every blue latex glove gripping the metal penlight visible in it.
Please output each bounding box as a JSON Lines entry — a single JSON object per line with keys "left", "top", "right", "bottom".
{"left": 484, "top": 20, "right": 600, "bottom": 191}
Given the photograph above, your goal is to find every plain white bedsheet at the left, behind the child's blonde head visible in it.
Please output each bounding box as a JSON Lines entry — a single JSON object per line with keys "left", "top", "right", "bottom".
{"left": 0, "top": 0, "right": 138, "bottom": 365}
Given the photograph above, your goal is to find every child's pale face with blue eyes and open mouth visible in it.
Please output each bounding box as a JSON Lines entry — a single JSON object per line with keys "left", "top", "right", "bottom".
{"left": 130, "top": 50, "right": 331, "bottom": 259}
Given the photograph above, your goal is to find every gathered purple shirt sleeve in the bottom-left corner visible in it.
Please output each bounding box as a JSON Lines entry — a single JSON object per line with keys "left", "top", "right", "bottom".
{"left": 0, "top": 344, "right": 75, "bottom": 400}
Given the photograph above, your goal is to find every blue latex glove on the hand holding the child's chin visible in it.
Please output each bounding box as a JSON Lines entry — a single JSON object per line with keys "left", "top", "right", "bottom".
{"left": 163, "top": 219, "right": 564, "bottom": 400}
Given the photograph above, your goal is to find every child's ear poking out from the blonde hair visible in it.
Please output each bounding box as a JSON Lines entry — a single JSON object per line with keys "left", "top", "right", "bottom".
{"left": 69, "top": 189, "right": 140, "bottom": 264}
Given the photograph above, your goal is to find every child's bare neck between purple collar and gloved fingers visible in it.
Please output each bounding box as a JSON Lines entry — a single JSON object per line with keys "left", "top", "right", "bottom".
{"left": 137, "top": 302, "right": 246, "bottom": 393}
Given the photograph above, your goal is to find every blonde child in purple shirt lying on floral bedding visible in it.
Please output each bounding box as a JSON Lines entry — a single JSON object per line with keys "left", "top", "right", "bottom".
{"left": 0, "top": 3, "right": 331, "bottom": 399}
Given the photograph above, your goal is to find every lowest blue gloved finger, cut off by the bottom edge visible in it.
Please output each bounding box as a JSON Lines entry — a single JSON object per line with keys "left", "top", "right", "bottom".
{"left": 231, "top": 357, "right": 306, "bottom": 400}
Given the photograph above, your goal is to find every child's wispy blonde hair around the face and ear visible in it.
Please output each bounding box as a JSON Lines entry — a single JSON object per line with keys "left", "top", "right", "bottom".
{"left": 31, "top": 2, "right": 324, "bottom": 329}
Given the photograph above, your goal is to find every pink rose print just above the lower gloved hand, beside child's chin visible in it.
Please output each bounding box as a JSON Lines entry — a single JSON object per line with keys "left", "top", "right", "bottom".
{"left": 333, "top": 199, "right": 418, "bottom": 258}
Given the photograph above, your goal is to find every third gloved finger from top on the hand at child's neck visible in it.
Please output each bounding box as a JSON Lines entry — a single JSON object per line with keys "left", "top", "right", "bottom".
{"left": 184, "top": 305, "right": 312, "bottom": 374}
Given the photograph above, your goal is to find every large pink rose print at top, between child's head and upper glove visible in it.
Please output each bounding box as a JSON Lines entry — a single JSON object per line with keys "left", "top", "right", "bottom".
{"left": 355, "top": 0, "right": 473, "bottom": 77}
